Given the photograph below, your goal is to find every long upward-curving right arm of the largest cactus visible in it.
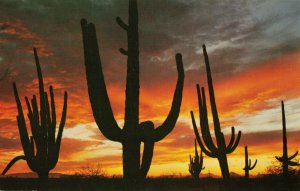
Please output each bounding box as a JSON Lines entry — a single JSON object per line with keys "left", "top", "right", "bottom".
{"left": 154, "top": 54, "right": 184, "bottom": 142}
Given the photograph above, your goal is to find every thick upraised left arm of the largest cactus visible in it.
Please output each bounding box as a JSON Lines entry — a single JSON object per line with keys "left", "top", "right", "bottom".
{"left": 81, "top": 19, "right": 122, "bottom": 141}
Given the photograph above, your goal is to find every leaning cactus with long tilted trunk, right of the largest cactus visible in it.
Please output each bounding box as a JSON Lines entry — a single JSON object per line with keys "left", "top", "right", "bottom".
{"left": 191, "top": 45, "right": 241, "bottom": 179}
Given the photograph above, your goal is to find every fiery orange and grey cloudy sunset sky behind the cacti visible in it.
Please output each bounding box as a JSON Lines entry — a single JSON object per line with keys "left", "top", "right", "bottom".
{"left": 0, "top": 0, "right": 300, "bottom": 176}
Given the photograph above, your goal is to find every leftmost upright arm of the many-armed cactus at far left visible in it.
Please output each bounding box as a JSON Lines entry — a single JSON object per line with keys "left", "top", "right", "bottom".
{"left": 13, "top": 83, "right": 30, "bottom": 155}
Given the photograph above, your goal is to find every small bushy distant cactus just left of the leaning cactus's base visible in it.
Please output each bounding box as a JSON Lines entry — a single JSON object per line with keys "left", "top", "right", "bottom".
{"left": 189, "top": 139, "right": 205, "bottom": 179}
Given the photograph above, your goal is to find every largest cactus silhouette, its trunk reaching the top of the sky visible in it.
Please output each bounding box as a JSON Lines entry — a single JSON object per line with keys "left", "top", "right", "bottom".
{"left": 81, "top": 0, "right": 184, "bottom": 180}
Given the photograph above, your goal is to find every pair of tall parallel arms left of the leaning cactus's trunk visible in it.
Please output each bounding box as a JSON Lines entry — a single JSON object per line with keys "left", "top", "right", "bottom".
{"left": 197, "top": 84, "right": 217, "bottom": 152}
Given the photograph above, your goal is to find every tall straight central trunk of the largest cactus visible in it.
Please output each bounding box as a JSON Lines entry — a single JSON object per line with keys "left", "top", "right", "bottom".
{"left": 122, "top": 0, "right": 141, "bottom": 179}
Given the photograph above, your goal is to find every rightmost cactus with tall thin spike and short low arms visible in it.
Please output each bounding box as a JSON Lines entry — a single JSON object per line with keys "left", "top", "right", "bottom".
{"left": 275, "top": 101, "right": 300, "bottom": 177}
